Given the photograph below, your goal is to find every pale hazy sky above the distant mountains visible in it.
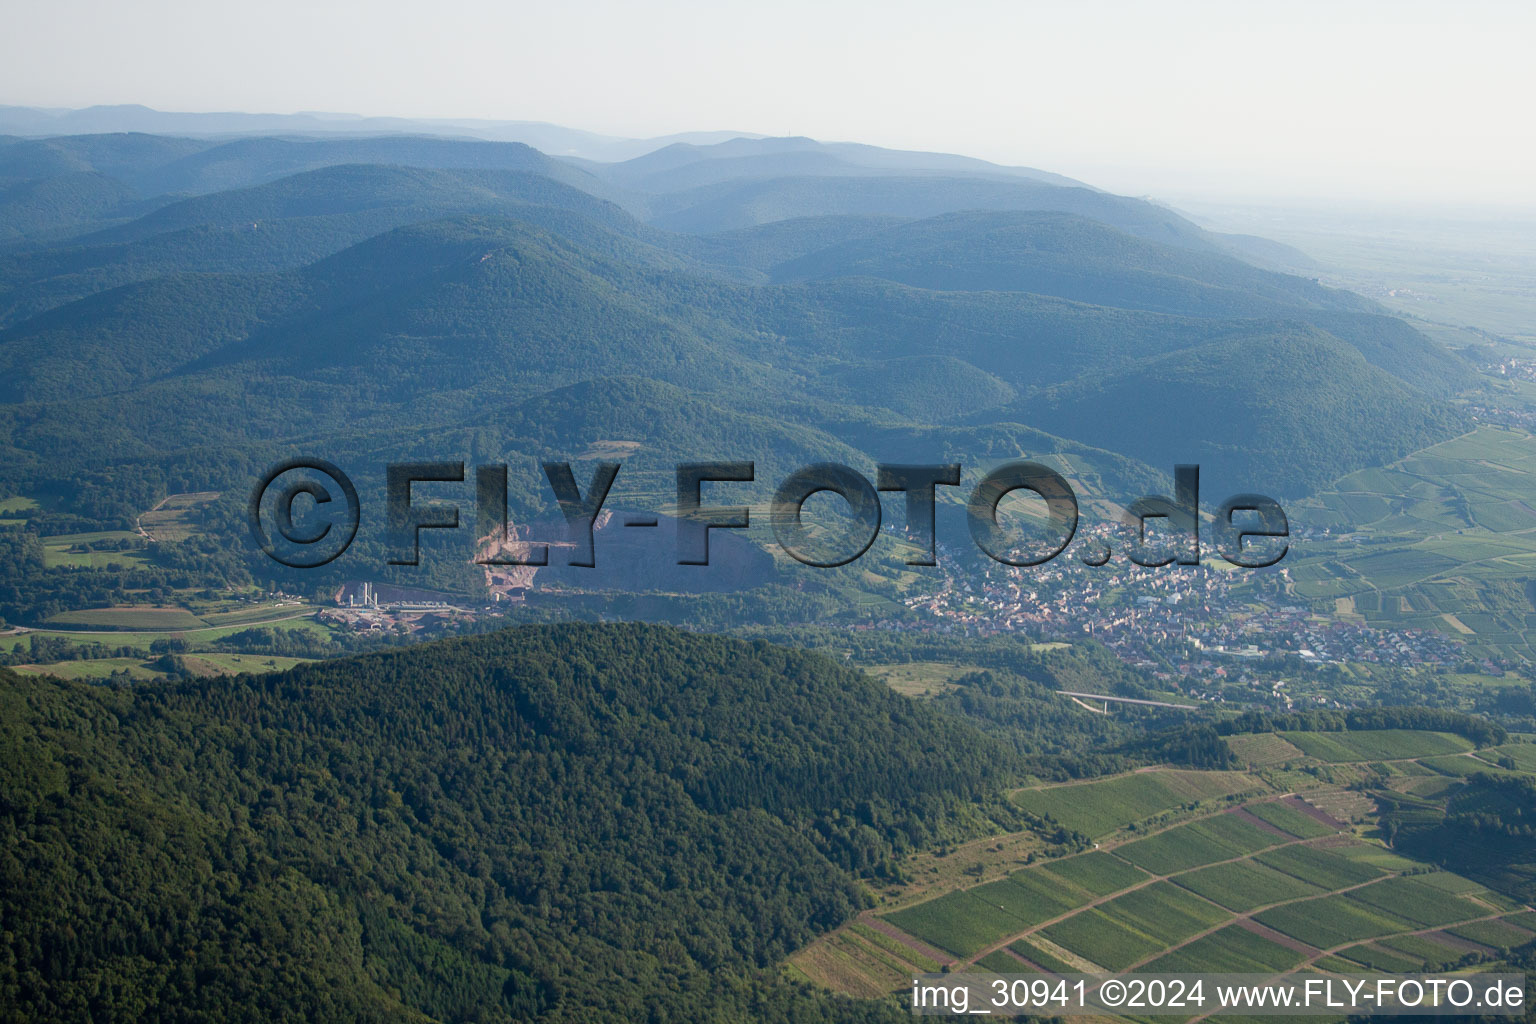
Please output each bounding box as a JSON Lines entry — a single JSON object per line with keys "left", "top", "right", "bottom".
{"left": 0, "top": 0, "right": 1536, "bottom": 204}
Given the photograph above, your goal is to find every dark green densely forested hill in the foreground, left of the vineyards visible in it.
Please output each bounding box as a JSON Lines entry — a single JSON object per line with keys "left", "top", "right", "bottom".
{"left": 0, "top": 625, "right": 1009, "bottom": 1022}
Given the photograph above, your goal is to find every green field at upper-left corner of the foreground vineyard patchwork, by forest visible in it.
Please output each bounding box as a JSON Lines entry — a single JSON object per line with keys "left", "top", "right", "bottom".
{"left": 1014, "top": 771, "right": 1260, "bottom": 837}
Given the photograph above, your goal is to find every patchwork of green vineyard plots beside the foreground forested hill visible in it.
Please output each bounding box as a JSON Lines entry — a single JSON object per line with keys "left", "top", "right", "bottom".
{"left": 797, "top": 731, "right": 1536, "bottom": 1007}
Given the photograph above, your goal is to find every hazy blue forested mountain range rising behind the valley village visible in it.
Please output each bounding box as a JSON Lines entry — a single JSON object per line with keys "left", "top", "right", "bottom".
{"left": 0, "top": 118, "right": 1475, "bottom": 577}
